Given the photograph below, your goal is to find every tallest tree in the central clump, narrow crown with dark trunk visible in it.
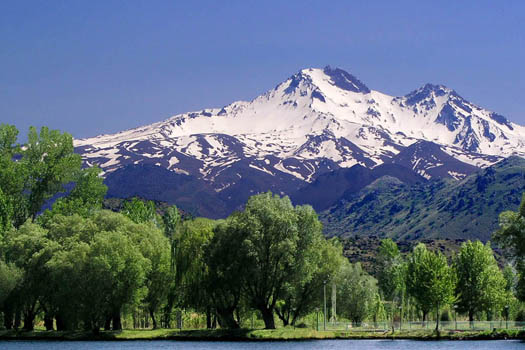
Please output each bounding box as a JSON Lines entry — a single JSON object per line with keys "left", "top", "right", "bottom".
{"left": 238, "top": 192, "right": 300, "bottom": 329}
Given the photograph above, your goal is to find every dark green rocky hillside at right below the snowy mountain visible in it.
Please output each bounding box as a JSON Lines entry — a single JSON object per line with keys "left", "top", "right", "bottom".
{"left": 320, "top": 157, "right": 525, "bottom": 241}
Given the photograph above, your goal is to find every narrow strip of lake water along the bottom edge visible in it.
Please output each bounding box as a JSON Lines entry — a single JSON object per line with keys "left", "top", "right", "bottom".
{"left": 0, "top": 340, "right": 525, "bottom": 350}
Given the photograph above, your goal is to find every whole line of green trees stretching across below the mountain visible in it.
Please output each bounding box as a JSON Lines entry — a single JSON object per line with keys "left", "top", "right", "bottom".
{"left": 0, "top": 124, "right": 525, "bottom": 332}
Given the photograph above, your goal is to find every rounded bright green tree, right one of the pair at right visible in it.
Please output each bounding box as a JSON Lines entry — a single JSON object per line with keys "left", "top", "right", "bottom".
{"left": 454, "top": 241, "right": 506, "bottom": 322}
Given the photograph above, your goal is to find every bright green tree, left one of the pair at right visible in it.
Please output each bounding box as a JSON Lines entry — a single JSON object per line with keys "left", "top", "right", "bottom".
{"left": 407, "top": 243, "right": 456, "bottom": 330}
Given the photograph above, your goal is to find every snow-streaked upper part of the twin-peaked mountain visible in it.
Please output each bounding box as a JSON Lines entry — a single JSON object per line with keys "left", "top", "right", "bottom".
{"left": 75, "top": 67, "right": 525, "bottom": 209}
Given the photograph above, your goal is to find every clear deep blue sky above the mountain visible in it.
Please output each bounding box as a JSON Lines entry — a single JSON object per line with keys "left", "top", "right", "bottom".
{"left": 0, "top": 0, "right": 525, "bottom": 137}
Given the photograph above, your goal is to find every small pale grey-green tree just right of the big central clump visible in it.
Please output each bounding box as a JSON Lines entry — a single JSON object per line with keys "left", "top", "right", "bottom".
{"left": 336, "top": 262, "right": 378, "bottom": 326}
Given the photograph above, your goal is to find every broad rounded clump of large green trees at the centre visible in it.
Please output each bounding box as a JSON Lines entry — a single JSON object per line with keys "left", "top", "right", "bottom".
{"left": 203, "top": 193, "right": 342, "bottom": 328}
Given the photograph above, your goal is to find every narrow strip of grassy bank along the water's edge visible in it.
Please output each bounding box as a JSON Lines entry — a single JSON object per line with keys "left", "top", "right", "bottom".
{"left": 0, "top": 328, "right": 525, "bottom": 341}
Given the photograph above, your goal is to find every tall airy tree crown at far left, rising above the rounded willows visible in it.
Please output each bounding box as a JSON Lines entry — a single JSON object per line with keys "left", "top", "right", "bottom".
{"left": 0, "top": 124, "right": 81, "bottom": 227}
